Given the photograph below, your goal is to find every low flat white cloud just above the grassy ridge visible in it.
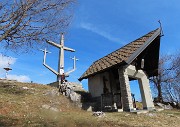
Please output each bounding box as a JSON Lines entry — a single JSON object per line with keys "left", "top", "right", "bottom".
{"left": 7, "top": 75, "right": 31, "bottom": 82}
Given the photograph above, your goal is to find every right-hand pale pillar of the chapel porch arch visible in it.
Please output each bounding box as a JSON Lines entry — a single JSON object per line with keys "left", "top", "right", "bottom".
{"left": 138, "top": 75, "right": 154, "bottom": 110}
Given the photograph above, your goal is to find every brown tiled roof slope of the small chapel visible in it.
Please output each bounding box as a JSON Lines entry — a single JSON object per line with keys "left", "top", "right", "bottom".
{"left": 79, "top": 28, "right": 159, "bottom": 81}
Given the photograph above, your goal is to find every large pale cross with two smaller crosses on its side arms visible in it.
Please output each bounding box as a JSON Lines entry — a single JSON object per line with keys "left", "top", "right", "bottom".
{"left": 42, "top": 33, "right": 77, "bottom": 81}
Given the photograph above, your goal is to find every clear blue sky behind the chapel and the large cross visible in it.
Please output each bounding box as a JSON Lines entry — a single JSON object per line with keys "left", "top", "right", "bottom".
{"left": 0, "top": 0, "right": 180, "bottom": 98}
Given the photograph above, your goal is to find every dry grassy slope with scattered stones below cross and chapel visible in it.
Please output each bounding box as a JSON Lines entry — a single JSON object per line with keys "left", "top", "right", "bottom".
{"left": 0, "top": 82, "right": 180, "bottom": 127}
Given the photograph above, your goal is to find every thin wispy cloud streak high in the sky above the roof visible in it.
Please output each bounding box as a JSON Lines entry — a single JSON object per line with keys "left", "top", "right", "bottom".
{"left": 80, "top": 23, "right": 123, "bottom": 44}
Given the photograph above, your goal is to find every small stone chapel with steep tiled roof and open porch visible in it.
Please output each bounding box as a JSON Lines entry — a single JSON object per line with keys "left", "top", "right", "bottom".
{"left": 79, "top": 28, "right": 161, "bottom": 111}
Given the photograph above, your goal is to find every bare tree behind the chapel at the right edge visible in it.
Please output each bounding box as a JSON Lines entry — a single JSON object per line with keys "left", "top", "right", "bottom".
{"left": 150, "top": 52, "right": 180, "bottom": 107}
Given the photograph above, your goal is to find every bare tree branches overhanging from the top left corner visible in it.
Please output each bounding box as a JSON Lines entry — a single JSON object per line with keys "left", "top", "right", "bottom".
{"left": 0, "top": 0, "right": 76, "bottom": 49}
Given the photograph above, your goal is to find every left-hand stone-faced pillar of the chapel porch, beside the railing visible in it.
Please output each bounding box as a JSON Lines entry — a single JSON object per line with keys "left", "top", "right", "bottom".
{"left": 118, "top": 68, "right": 134, "bottom": 111}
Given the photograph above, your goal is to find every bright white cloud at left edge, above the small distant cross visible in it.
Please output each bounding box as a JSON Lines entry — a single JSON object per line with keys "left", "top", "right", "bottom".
{"left": 0, "top": 54, "right": 16, "bottom": 68}
